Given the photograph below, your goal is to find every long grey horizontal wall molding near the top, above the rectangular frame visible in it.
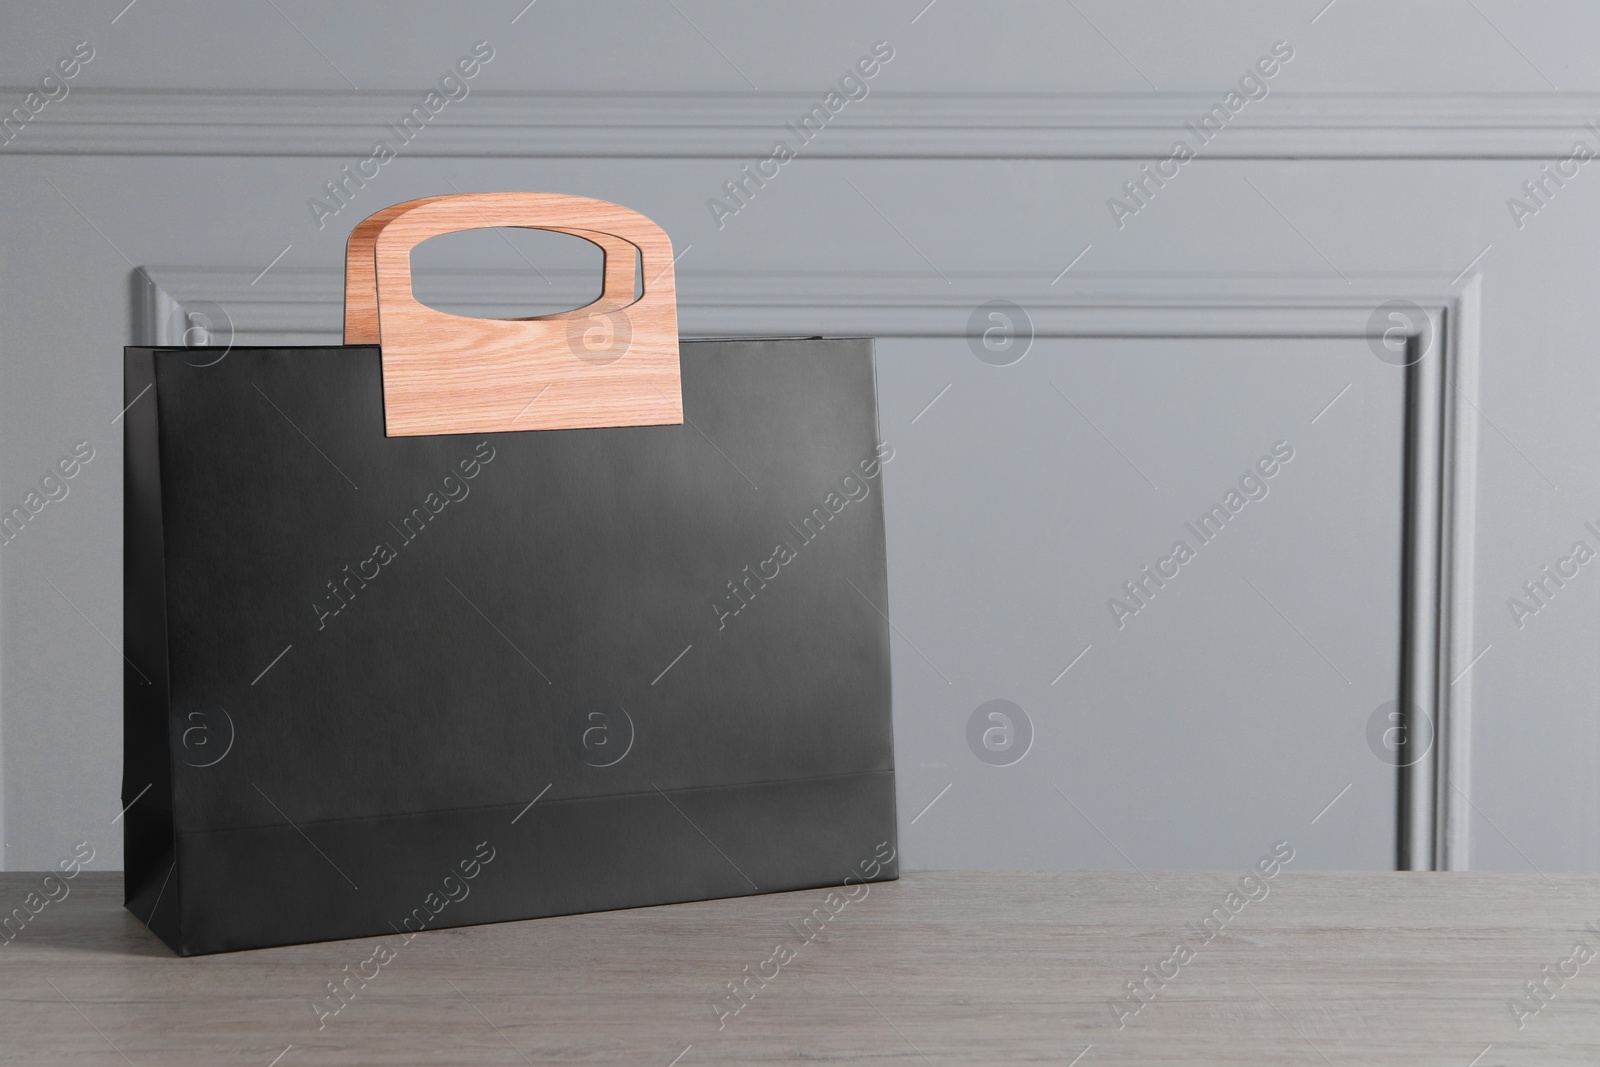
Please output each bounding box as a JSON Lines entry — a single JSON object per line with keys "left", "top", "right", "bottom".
{"left": 12, "top": 86, "right": 1600, "bottom": 160}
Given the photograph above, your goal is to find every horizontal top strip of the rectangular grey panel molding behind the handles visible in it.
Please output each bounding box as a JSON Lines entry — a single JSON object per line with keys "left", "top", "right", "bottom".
{"left": 136, "top": 266, "right": 1475, "bottom": 344}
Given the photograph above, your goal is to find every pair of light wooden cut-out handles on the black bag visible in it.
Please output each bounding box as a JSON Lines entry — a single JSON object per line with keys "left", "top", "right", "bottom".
{"left": 344, "top": 192, "right": 683, "bottom": 437}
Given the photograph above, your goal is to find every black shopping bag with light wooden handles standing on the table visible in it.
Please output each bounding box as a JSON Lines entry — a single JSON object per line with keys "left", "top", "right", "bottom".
{"left": 122, "top": 194, "right": 898, "bottom": 955}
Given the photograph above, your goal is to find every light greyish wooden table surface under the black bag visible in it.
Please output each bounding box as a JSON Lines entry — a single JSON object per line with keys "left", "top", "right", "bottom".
{"left": 0, "top": 870, "right": 1600, "bottom": 1067}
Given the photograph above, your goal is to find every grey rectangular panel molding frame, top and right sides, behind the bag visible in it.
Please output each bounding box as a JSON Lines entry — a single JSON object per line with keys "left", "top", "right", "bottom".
{"left": 133, "top": 266, "right": 1482, "bottom": 870}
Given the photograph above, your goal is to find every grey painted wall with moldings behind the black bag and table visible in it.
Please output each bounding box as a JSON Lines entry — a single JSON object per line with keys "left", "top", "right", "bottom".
{"left": 0, "top": 0, "right": 1600, "bottom": 872}
